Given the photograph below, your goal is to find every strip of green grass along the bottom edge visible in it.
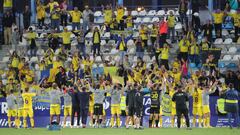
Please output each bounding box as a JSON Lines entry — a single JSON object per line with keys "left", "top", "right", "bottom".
{"left": 0, "top": 128, "right": 240, "bottom": 135}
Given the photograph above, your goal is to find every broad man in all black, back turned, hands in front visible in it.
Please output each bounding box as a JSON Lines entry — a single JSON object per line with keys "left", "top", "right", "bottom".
{"left": 172, "top": 85, "right": 191, "bottom": 130}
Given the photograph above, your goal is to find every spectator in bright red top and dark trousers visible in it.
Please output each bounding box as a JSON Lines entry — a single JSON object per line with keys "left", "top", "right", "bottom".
{"left": 159, "top": 18, "right": 168, "bottom": 48}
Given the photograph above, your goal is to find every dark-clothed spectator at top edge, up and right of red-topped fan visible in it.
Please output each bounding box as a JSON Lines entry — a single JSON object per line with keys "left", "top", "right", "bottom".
{"left": 178, "top": 0, "right": 188, "bottom": 30}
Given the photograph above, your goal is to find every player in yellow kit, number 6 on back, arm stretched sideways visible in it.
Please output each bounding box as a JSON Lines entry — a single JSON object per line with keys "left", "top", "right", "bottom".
{"left": 22, "top": 88, "right": 36, "bottom": 128}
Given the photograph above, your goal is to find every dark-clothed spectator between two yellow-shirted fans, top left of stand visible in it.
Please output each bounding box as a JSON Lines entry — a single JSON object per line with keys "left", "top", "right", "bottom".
{"left": 60, "top": 0, "right": 68, "bottom": 27}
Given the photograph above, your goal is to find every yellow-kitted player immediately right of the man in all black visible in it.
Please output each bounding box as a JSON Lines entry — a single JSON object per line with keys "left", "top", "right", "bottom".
{"left": 192, "top": 84, "right": 204, "bottom": 127}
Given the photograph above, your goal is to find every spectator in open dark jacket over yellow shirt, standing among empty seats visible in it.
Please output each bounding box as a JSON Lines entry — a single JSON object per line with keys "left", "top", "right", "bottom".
{"left": 92, "top": 27, "right": 101, "bottom": 57}
